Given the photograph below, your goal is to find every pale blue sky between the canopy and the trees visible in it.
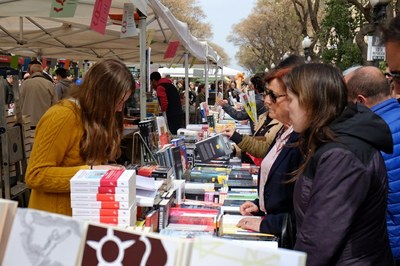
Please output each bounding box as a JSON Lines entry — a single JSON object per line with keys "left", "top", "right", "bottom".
{"left": 197, "top": 0, "right": 256, "bottom": 71}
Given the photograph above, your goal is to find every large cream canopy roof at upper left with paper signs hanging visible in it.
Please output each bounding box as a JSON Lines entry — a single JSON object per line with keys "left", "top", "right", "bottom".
{"left": 0, "top": 0, "right": 217, "bottom": 63}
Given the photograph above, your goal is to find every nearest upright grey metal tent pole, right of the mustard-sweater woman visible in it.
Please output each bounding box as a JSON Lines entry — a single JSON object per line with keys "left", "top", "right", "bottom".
{"left": 138, "top": 11, "right": 149, "bottom": 121}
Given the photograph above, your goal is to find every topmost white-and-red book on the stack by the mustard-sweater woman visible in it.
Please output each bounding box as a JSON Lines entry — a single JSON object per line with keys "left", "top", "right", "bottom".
{"left": 70, "top": 169, "right": 136, "bottom": 188}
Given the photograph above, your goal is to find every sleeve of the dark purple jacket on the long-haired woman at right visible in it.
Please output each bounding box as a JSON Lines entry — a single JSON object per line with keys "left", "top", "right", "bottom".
{"left": 294, "top": 148, "right": 371, "bottom": 266}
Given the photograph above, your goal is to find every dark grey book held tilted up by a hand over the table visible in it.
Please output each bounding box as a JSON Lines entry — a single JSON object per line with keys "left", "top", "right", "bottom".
{"left": 196, "top": 134, "right": 232, "bottom": 162}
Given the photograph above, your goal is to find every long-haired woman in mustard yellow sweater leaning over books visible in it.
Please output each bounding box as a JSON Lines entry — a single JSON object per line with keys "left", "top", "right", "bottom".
{"left": 25, "top": 59, "right": 135, "bottom": 215}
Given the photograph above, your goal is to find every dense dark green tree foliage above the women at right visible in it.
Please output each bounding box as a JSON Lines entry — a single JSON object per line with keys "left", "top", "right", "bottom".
{"left": 319, "top": 0, "right": 362, "bottom": 70}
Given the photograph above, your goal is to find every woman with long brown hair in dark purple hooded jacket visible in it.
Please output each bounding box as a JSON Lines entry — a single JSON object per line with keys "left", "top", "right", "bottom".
{"left": 286, "top": 63, "right": 393, "bottom": 266}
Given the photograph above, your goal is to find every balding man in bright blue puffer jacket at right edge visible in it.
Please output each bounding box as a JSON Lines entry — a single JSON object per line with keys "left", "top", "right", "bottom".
{"left": 345, "top": 67, "right": 400, "bottom": 265}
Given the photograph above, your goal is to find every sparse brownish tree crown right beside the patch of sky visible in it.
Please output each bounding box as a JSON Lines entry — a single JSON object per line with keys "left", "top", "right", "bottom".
{"left": 228, "top": 0, "right": 301, "bottom": 73}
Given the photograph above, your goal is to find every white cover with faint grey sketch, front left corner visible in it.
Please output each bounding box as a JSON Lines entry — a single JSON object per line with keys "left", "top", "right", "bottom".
{"left": 2, "top": 208, "right": 86, "bottom": 266}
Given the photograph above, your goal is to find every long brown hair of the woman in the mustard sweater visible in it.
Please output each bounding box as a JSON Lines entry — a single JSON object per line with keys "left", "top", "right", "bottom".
{"left": 70, "top": 59, "right": 135, "bottom": 164}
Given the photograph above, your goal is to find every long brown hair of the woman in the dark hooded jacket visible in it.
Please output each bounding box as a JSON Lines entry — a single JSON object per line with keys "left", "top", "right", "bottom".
{"left": 285, "top": 63, "right": 347, "bottom": 179}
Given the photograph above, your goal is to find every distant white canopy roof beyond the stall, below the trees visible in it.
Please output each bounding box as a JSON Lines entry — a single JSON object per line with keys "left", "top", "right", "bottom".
{"left": 158, "top": 67, "right": 242, "bottom": 78}
